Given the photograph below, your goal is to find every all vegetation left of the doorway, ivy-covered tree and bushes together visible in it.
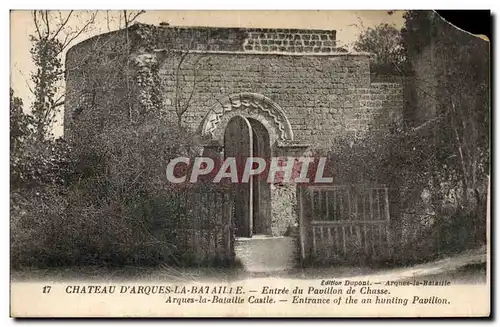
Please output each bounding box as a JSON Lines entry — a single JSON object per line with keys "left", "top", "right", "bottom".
{"left": 10, "top": 11, "right": 231, "bottom": 268}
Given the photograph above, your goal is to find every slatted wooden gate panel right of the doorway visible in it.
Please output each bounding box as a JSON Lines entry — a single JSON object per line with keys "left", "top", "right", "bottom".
{"left": 299, "top": 185, "right": 391, "bottom": 263}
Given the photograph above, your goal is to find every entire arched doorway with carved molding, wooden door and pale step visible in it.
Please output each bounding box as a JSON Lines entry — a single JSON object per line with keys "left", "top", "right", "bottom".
{"left": 200, "top": 93, "right": 303, "bottom": 272}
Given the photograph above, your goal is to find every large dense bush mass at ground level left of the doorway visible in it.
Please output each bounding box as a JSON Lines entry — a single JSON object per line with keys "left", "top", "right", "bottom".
{"left": 11, "top": 119, "right": 235, "bottom": 268}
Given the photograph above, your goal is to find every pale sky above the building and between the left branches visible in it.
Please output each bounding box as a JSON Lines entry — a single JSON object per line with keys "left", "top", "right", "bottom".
{"left": 10, "top": 10, "right": 404, "bottom": 137}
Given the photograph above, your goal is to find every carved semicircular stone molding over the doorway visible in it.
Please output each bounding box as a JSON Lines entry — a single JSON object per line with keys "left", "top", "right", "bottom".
{"left": 201, "top": 93, "right": 293, "bottom": 142}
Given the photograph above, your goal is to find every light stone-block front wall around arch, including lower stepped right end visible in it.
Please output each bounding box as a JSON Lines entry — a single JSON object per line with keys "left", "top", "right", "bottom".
{"left": 160, "top": 53, "right": 402, "bottom": 148}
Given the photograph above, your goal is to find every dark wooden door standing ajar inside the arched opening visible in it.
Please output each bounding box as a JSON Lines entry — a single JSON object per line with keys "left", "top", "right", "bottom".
{"left": 224, "top": 115, "right": 271, "bottom": 237}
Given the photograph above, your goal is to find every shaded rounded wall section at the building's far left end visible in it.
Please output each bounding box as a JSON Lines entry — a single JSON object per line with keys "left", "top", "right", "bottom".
{"left": 64, "top": 31, "right": 135, "bottom": 140}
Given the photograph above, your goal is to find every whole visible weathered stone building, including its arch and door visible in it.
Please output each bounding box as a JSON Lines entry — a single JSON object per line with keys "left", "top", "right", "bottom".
{"left": 65, "top": 24, "right": 403, "bottom": 246}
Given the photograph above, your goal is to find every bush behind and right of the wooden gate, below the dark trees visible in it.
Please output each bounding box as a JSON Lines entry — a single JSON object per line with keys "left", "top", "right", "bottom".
{"left": 320, "top": 128, "right": 486, "bottom": 264}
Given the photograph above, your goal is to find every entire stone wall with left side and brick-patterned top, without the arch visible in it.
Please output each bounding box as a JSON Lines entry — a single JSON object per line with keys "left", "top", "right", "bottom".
{"left": 65, "top": 25, "right": 402, "bottom": 148}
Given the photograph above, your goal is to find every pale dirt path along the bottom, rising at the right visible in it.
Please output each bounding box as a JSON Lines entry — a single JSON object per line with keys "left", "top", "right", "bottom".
{"left": 11, "top": 246, "right": 487, "bottom": 283}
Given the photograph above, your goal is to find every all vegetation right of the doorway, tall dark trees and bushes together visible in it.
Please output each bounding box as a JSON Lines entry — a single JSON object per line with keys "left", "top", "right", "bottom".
{"left": 330, "top": 10, "right": 490, "bottom": 263}
